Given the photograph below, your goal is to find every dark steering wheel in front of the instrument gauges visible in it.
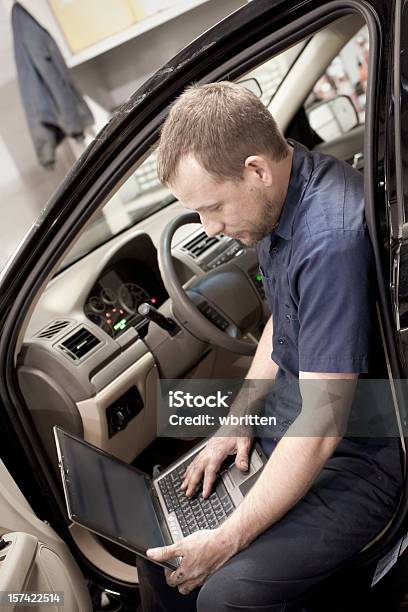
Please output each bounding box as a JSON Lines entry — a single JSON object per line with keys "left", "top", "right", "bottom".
{"left": 158, "top": 212, "right": 262, "bottom": 355}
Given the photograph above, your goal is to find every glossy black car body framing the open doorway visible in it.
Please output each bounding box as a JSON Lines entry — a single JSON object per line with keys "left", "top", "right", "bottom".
{"left": 0, "top": 0, "right": 408, "bottom": 610}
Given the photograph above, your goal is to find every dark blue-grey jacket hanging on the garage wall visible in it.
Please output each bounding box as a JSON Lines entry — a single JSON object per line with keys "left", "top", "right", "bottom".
{"left": 11, "top": 2, "right": 94, "bottom": 168}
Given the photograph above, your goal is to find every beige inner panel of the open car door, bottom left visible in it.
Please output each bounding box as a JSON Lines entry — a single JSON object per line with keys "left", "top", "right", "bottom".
{"left": 0, "top": 461, "right": 92, "bottom": 612}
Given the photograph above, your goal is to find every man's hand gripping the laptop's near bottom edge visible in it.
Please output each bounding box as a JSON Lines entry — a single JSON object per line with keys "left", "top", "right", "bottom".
{"left": 147, "top": 529, "right": 238, "bottom": 595}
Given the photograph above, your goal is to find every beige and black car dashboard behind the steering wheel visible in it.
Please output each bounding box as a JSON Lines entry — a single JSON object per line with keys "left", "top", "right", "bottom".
{"left": 17, "top": 203, "right": 264, "bottom": 465}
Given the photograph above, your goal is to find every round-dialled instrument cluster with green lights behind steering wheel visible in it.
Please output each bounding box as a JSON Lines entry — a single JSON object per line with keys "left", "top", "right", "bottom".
{"left": 84, "top": 259, "right": 168, "bottom": 338}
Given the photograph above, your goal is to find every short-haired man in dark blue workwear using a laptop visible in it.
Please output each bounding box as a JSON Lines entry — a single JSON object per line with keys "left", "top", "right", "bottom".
{"left": 138, "top": 82, "right": 400, "bottom": 612}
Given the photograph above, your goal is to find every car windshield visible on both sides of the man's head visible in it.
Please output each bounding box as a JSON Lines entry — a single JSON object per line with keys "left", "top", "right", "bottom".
{"left": 59, "top": 41, "right": 306, "bottom": 271}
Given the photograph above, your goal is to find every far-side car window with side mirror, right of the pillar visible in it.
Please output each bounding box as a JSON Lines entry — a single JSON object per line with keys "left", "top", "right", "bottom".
{"left": 305, "top": 26, "right": 368, "bottom": 142}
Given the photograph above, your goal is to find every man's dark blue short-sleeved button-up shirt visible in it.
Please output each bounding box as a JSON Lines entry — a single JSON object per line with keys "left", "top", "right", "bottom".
{"left": 257, "top": 142, "right": 376, "bottom": 378}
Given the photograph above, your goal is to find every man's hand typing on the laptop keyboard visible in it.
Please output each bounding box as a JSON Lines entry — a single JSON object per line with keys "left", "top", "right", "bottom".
{"left": 181, "top": 436, "right": 252, "bottom": 498}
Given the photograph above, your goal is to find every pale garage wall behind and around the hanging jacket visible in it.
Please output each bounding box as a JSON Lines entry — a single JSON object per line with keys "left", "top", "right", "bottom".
{"left": 0, "top": 0, "right": 246, "bottom": 269}
